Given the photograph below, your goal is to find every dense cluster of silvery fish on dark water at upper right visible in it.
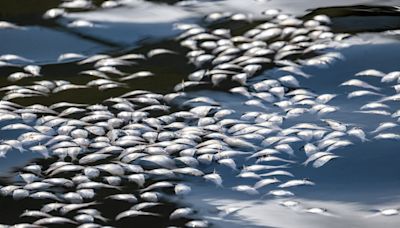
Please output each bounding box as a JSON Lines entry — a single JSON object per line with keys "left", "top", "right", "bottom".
{"left": 178, "top": 10, "right": 348, "bottom": 87}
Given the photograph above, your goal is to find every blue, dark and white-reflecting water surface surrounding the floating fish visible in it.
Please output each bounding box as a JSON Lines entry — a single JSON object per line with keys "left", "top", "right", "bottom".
{"left": 0, "top": 0, "right": 400, "bottom": 227}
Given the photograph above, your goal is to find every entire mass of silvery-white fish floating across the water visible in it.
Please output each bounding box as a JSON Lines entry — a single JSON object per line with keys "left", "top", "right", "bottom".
{"left": 0, "top": 0, "right": 400, "bottom": 227}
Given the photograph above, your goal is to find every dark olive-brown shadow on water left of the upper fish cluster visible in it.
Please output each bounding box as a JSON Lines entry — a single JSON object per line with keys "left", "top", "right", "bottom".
{"left": 0, "top": 37, "right": 194, "bottom": 108}
